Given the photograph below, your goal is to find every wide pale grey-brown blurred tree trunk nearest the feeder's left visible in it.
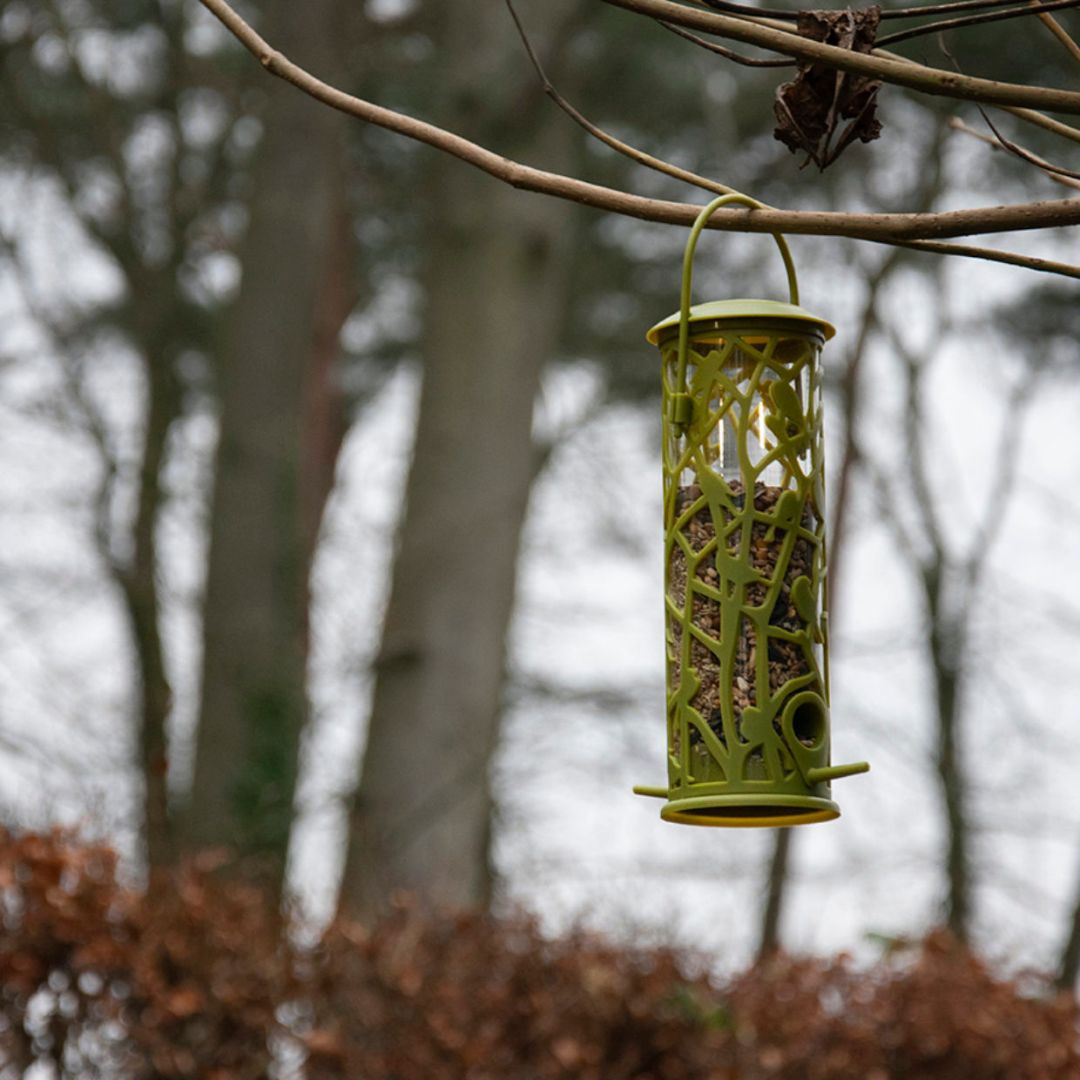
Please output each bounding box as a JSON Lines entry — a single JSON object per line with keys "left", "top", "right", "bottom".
{"left": 340, "top": 0, "right": 577, "bottom": 918}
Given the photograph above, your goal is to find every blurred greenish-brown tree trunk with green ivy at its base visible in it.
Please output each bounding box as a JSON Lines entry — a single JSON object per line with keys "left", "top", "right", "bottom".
{"left": 184, "top": 0, "right": 349, "bottom": 888}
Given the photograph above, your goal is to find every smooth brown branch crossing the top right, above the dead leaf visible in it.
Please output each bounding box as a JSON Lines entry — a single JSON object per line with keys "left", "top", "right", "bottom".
{"left": 603, "top": 0, "right": 1080, "bottom": 114}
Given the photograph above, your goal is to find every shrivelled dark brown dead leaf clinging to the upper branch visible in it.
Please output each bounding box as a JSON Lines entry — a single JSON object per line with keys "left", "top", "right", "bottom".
{"left": 773, "top": 4, "right": 881, "bottom": 171}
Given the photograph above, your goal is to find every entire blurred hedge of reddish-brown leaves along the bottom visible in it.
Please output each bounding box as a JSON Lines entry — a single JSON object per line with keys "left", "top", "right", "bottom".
{"left": 0, "top": 832, "right": 1080, "bottom": 1080}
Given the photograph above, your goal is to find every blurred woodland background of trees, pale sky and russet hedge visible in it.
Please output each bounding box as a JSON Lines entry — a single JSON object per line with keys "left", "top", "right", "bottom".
{"left": 0, "top": 0, "right": 1080, "bottom": 1080}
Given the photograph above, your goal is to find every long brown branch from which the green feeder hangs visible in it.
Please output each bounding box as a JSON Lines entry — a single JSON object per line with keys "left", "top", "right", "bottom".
{"left": 201, "top": 0, "right": 1080, "bottom": 278}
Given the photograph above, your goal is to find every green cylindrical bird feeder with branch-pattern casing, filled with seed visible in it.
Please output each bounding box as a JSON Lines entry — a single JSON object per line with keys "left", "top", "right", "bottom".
{"left": 634, "top": 194, "right": 869, "bottom": 826}
